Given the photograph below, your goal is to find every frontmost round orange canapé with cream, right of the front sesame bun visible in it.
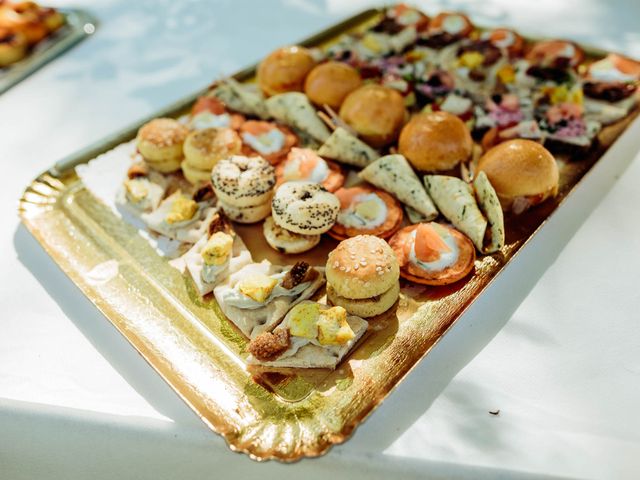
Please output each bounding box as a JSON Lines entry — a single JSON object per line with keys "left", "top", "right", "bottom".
{"left": 389, "top": 222, "right": 476, "bottom": 285}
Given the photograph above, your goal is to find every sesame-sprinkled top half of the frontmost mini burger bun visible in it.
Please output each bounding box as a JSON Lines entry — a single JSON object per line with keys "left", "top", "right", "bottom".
{"left": 326, "top": 235, "right": 400, "bottom": 298}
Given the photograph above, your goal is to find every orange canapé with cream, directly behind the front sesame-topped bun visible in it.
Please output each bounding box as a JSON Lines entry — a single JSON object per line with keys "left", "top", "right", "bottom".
{"left": 329, "top": 186, "right": 403, "bottom": 240}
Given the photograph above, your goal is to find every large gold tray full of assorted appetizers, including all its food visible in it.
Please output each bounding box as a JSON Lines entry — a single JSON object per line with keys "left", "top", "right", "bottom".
{"left": 20, "top": 4, "right": 640, "bottom": 460}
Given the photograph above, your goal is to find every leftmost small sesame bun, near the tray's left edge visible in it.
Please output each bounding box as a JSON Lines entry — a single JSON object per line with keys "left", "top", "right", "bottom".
{"left": 138, "top": 118, "right": 189, "bottom": 167}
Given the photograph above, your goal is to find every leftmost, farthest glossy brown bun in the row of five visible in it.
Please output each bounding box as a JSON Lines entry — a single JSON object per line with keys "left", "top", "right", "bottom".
{"left": 257, "top": 46, "right": 316, "bottom": 96}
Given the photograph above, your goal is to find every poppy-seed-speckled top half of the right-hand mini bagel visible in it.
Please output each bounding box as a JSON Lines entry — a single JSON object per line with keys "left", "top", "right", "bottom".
{"left": 271, "top": 181, "right": 340, "bottom": 235}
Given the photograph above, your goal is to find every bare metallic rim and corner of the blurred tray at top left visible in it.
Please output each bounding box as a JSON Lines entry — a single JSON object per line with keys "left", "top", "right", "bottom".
{"left": 0, "top": 8, "right": 98, "bottom": 94}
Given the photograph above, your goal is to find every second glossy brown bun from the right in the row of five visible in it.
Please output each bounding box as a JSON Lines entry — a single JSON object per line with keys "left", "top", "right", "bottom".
{"left": 398, "top": 112, "right": 473, "bottom": 171}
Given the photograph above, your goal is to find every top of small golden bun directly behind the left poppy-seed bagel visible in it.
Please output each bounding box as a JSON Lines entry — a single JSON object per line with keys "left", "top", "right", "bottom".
{"left": 184, "top": 128, "right": 242, "bottom": 171}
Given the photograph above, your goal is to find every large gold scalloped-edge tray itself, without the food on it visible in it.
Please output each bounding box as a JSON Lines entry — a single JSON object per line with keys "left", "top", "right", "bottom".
{"left": 19, "top": 10, "right": 637, "bottom": 461}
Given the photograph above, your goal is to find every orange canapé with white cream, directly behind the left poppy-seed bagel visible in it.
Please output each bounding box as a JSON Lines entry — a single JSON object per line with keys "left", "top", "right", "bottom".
{"left": 240, "top": 120, "right": 298, "bottom": 165}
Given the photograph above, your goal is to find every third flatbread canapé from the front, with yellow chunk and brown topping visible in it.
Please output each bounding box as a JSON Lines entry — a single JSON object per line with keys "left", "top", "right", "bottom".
{"left": 183, "top": 212, "right": 252, "bottom": 297}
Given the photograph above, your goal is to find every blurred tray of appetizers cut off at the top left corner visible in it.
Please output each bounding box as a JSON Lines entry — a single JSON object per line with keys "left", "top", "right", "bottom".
{"left": 0, "top": 0, "right": 96, "bottom": 93}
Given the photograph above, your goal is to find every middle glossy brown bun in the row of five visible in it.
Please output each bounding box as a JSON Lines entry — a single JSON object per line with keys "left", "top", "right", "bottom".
{"left": 340, "top": 84, "right": 407, "bottom": 147}
